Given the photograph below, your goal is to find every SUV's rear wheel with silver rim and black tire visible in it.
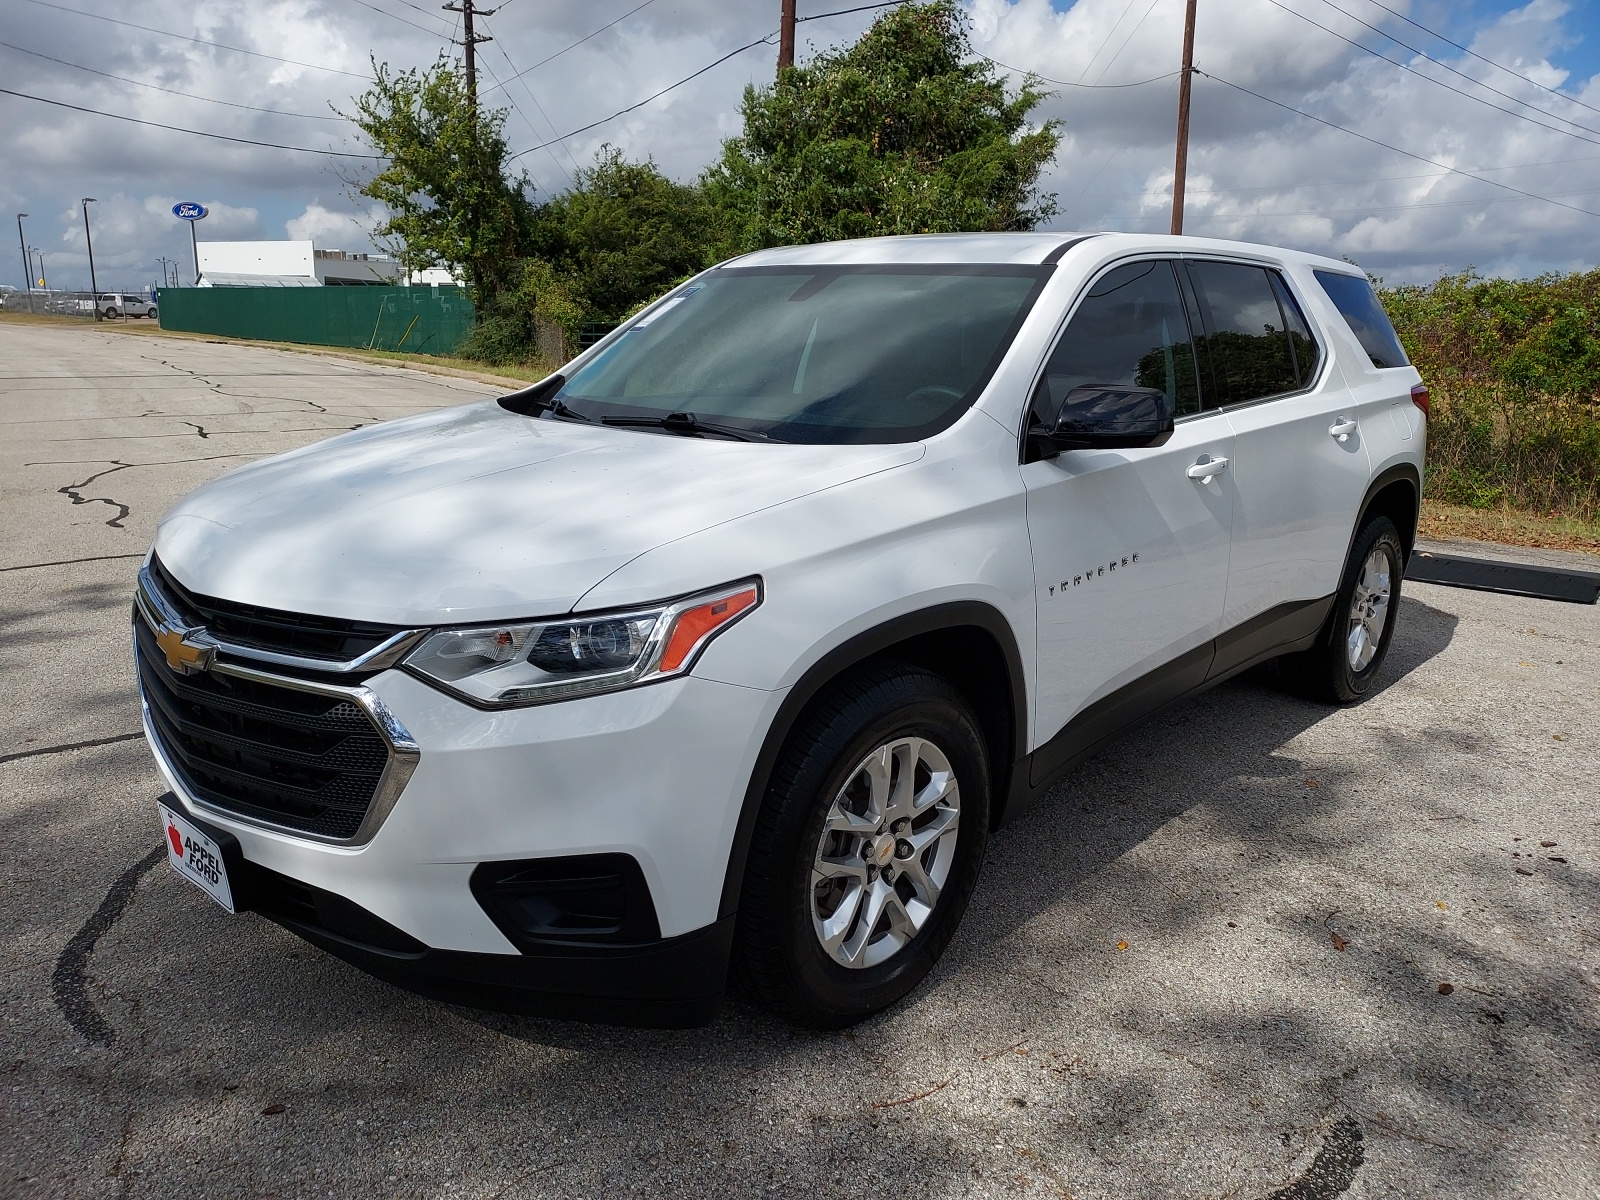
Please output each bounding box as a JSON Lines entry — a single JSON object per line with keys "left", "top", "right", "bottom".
{"left": 1278, "top": 517, "right": 1405, "bottom": 704}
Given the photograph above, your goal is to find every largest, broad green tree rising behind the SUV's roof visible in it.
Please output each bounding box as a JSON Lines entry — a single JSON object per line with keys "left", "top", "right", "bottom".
{"left": 704, "top": 0, "right": 1059, "bottom": 251}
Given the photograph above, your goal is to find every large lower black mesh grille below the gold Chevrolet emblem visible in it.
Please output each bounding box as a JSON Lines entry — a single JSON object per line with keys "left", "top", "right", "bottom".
{"left": 133, "top": 616, "right": 389, "bottom": 838}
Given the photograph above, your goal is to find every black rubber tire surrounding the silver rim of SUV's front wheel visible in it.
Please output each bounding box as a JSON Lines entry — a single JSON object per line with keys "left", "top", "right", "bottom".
{"left": 734, "top": 664, "right": 990, "bottom": 1029}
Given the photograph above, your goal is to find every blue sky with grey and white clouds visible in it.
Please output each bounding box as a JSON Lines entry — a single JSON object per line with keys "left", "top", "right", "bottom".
{"left": 0, "top": 0, "right": 1600, "bottom": 290}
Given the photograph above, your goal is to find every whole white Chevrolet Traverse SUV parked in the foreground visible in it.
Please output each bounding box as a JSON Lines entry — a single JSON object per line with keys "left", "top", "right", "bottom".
{"left": 134, "top": 234, "right": 1427, "bottom": 1027}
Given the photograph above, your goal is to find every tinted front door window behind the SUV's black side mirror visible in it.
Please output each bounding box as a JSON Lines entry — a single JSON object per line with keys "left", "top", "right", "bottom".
{"left": 1034, "top": 262, "right": 1200, "bottom": 426}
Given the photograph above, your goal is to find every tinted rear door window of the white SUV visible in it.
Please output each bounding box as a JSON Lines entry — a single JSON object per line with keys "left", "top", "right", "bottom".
{"left": 1189, "top": 262, "right": 1299, "bottom": 406}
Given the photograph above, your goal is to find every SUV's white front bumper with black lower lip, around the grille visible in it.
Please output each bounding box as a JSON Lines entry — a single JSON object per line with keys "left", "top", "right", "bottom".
{"left": 146, "top": 659, "right": 782, "bottom": 1026}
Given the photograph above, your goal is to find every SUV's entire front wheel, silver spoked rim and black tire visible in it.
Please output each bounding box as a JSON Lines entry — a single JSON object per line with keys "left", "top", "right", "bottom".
{"left": 738, "top": 664, "right": 990, "bottom": 1029}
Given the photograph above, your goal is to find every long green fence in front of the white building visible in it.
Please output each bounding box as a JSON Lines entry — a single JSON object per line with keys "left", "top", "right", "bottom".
{"left": 157, "top": 286, "right": 472, "bottom": 354}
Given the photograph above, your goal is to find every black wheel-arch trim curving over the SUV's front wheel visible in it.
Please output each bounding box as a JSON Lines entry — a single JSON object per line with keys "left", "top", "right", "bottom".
{"left": 717, "top": 600, "right": 1027, "bottom": 917}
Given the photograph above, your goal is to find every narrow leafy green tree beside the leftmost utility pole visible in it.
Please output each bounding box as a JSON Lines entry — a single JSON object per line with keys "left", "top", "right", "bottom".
{"left": 350, "top": 54, "right": 533, "bottom": 307}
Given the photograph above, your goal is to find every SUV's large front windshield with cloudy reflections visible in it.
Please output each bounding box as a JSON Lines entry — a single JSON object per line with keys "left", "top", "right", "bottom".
{"left": 558, "top": 264, "right": 1051, "bottom": 443}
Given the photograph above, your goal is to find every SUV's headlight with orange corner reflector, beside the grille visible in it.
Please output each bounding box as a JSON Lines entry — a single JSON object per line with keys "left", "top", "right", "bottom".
{"left": 403, "top": 579, "right": 762, "bottom": 707}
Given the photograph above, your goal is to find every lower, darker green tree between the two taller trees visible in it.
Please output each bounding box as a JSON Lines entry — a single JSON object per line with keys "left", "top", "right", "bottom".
{"left": 534, "top": 146, "right": 717, "bottom": 322}
